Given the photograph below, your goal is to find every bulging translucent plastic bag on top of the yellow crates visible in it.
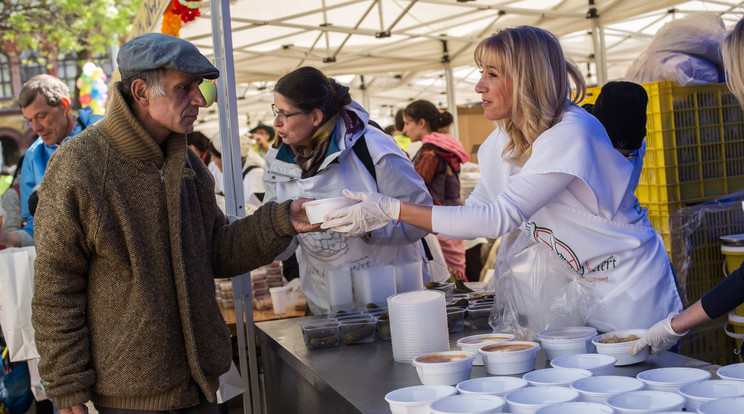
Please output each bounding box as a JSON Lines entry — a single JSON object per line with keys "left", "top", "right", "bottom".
{"left": 626, "top": 13, "right": 726, "bottom": 86}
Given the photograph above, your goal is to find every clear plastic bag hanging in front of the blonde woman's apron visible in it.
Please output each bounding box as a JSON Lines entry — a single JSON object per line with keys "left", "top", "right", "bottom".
{"left": 489, "top": 230, "right": 597, "bottom": 340}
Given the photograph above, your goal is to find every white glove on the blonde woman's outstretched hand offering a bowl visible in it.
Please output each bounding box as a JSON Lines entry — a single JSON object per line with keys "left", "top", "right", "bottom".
{"left": 320, "top": 190, "right": 400, "bottom": 237}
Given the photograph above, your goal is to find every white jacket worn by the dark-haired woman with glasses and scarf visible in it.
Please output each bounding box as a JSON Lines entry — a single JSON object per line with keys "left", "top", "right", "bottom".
{"left": 263, "top": 102, "right": 432, "bottom": 314}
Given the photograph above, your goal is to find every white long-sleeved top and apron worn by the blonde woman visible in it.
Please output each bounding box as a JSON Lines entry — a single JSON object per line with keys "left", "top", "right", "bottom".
{"left": 432, "top": 105, "right": 682, "bottom": 331}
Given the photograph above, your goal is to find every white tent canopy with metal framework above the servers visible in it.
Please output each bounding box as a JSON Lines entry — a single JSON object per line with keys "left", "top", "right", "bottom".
{"left": 135, "top": 0, "right": 742, "bottom": 132}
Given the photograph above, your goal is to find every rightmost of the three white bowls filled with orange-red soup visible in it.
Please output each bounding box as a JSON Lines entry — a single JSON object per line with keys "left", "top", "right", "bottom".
{"left": 478, "top": 341, "right": 540, "bottom": 375}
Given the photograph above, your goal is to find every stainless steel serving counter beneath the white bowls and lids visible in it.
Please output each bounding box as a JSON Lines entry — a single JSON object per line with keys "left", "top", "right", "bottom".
{"left": 256, "top": 318, "right": 717, "bottom": 414}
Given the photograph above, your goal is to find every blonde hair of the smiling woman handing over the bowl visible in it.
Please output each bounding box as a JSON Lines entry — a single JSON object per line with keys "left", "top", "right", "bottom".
{"left": 475, "top": 26, "right": 586, "bottom": 164}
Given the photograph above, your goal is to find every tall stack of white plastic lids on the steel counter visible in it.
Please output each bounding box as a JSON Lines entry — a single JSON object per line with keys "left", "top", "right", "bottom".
{"left": 387, "top": 290, "right": 449, "bottom": 362}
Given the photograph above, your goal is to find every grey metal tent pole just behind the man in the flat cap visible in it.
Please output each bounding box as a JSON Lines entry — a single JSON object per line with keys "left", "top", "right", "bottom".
{"left": 209, "top": 0, "right": 261, "bottom": 414}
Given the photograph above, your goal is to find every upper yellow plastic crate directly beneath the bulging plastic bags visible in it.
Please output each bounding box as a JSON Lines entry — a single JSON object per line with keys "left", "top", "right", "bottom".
{"left": 583, "top": 82, "right": 744, "bottom": 204}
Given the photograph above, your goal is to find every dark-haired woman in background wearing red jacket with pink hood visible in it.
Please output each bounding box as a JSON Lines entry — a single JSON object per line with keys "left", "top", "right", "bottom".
{"left": 403, "top": 100, "right": 470, "bottom": 280}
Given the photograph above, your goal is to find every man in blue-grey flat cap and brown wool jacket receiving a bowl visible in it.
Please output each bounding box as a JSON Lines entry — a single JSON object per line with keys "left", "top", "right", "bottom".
{"left": 32, "top": 33, "right": 318, "bottom": 414}
